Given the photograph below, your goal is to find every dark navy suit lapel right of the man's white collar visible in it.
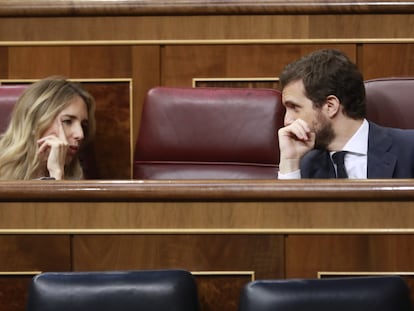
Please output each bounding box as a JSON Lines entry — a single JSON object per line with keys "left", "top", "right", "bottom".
{"left": 367, "top": 122, "right": 397, "bottom": 178}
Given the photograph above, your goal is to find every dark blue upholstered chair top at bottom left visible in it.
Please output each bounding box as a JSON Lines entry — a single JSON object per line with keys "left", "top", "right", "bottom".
{"left": 27, "top": 270, "right": 199, "bottom": 311}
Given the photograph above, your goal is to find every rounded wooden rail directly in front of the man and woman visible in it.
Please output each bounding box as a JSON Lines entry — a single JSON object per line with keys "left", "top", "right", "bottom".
{"left": 0, "top": 179, "right": 414, "bottom": 202}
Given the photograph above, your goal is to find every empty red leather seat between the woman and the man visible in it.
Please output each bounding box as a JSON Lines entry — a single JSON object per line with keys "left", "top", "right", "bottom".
{"left": 133, "top": 87, "right": 284, "bottom": 179}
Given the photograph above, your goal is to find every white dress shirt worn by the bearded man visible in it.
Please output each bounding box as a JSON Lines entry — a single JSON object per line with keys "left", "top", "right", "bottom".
{"left": 278, "top": 119, "right": 369, "bottom": 179}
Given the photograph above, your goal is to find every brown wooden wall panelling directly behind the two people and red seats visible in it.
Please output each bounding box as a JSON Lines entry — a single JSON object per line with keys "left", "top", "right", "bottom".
{"left": 0, "top": 40, "right": 414, "bottom": 179}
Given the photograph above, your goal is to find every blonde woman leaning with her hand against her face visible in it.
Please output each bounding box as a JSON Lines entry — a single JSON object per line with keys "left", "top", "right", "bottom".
{"left": 0, "top": 77, "right": 95, "bottom": 180}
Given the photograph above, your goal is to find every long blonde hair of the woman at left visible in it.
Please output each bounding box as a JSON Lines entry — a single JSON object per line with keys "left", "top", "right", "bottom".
{"left": 0, "top": 77, "right": 95, "bottom": 180}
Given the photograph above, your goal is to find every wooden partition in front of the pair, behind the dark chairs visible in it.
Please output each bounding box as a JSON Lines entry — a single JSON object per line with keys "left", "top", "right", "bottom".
{"left": 0, "top": 180, "right": 414, "bottom": 311}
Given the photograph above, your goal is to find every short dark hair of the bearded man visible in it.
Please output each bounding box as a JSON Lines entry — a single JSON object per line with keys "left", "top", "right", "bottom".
{"left": 280, "top": 49, "right": 366, "bottom": 119}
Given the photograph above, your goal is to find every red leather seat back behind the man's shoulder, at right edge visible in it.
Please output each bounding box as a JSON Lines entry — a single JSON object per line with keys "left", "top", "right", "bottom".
{"left": 365, "top": 77, "right": 414, "bottom": 129}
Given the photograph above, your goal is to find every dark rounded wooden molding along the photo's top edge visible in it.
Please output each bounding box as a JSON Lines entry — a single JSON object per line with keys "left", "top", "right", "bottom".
{"left": 0, "top": 0, "right": 414, "bottom": 17}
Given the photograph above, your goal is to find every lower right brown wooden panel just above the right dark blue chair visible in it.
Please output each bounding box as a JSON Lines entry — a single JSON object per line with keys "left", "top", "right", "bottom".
{"left": 286, "top": 234, "right": 414, "bottom": 278}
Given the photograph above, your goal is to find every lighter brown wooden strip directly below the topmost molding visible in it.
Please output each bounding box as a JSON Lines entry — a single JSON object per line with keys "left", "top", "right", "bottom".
{"left": 0, "top": 14, "right": 414, "bottom": 41}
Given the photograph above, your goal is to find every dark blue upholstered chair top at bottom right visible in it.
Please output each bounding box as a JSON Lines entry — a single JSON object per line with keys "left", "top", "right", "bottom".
{"left": 239, "top": 276, "right": 411, "bottom": 311}
